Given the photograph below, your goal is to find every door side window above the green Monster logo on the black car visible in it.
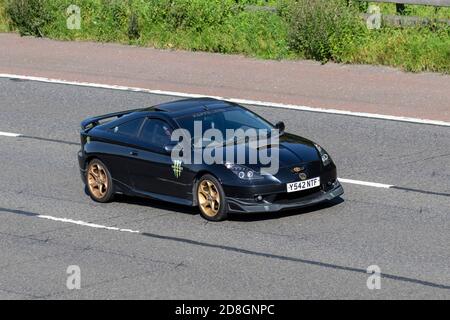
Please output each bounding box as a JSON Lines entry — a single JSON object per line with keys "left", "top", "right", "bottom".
{"left": 140, "top": 118, "right": 172, "bottom": 149}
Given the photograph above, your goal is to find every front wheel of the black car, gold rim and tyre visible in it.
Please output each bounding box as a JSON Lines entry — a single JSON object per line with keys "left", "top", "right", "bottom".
{"left": 196, "top": 174, "right": 228, "bottom": 221}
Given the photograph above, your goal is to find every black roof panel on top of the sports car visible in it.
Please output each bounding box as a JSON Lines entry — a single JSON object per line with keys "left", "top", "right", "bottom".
{"left": 142, "top": 98, "right": 237, "bottom": 118}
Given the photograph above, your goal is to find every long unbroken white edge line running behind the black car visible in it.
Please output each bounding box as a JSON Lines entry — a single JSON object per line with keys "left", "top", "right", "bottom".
{"left": 0, "top": 73, "right": 450, "bottom": 127}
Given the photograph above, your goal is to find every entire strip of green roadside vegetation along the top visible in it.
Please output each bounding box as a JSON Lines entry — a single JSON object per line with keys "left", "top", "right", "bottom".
{"left": 0, "top": 0, "right": 450, "bottom": 73}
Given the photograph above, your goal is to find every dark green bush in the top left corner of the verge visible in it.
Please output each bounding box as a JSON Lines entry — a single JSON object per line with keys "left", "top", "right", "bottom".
{"left": 6, "top": 0, "right": 51, "bottom": 37}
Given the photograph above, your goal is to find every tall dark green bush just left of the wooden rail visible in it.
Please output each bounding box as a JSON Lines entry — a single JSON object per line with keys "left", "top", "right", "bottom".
{"left": 284, "top": 0, "right": 363, "bottom": 61}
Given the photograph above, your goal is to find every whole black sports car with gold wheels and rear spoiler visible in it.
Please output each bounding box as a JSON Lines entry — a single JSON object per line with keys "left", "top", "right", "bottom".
{"left": 78, "top": 98, "right": 344, "bottom": 221}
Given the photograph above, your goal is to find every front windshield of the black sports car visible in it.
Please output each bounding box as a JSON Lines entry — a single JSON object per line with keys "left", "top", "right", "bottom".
{"left": 176, "top": 107, "right": 274, "bottom": 145}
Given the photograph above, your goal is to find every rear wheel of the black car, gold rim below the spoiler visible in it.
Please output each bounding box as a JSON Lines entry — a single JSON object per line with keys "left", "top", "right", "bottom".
{"left": 86, "top": 159, "right": 114, "bottom": 203}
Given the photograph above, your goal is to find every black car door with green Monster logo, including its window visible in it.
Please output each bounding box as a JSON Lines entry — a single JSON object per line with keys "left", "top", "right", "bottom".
{"left": 129, "top": 118, "right": 193, "bottom": 200}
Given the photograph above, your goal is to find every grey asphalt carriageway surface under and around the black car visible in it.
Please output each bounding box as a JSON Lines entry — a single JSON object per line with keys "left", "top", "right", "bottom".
{"left": 0, "top": 79, "right": 450, "bottom": 299}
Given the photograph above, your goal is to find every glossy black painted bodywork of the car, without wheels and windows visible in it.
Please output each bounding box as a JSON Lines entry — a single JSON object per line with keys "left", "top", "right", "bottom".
{"left": 78, "top": 98, "right": 344, "bottom": 213}
